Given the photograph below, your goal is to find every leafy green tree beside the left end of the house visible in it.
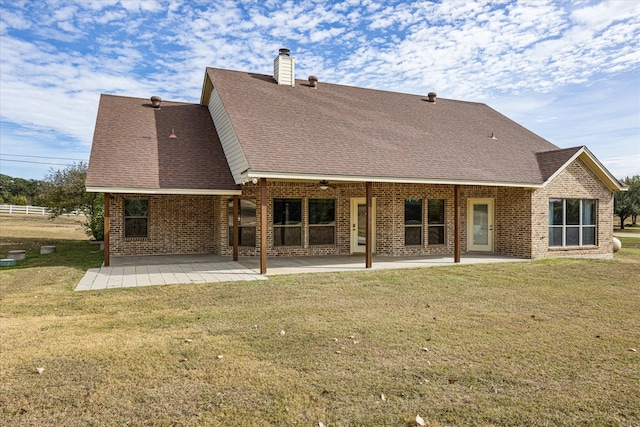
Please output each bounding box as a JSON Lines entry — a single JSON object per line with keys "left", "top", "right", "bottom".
{"left": 41, "top": 162, "right": 104, "bottom": 240}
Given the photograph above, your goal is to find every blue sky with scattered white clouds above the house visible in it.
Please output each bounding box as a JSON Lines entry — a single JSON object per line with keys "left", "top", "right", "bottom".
{"left": 0, "top": 0, "right": 640, "bottom": 179}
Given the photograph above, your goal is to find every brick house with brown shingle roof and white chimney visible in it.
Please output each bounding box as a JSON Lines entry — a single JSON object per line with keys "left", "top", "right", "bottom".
{"left": 86, "top": 49, "right": 624, "bottom": 273}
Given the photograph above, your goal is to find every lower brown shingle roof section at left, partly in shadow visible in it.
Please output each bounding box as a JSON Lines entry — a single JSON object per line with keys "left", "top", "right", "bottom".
{"left": 86, "top": 95, "right": 238, "bottom": 190}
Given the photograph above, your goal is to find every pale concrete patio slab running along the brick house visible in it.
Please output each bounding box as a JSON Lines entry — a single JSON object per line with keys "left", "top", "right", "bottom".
{"left": 75, "top": 254, "right": 528, "bottom": 291}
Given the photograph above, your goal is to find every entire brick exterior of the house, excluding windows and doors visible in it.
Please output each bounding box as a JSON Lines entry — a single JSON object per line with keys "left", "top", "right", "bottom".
{"left": 110, "top": 161, "right": 613, "bottom": 258}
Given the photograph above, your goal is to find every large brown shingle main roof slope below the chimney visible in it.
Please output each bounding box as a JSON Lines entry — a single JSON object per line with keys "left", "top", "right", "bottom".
{"left": 207, "top": 68, "right": 558, "bottom": 184}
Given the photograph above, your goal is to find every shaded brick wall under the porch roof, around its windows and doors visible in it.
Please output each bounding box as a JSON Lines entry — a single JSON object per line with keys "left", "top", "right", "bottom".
{"left": 216, "top": 181, "right": 531, "bottom": 257}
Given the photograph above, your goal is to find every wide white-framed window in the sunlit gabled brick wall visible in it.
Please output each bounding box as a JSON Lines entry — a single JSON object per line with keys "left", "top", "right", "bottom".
{"left": 549, "top": 199, "right": 598, "bottom": 247}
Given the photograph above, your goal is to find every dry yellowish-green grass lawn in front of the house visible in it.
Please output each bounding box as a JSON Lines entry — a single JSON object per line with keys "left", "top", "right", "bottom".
{"left": 0, "top": 217, "right": 640, "bottom": 426}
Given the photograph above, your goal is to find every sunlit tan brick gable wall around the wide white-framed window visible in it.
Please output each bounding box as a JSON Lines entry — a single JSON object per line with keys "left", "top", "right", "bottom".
{"left": 531, "top": 159, "right": 613, "bottom": 258}
